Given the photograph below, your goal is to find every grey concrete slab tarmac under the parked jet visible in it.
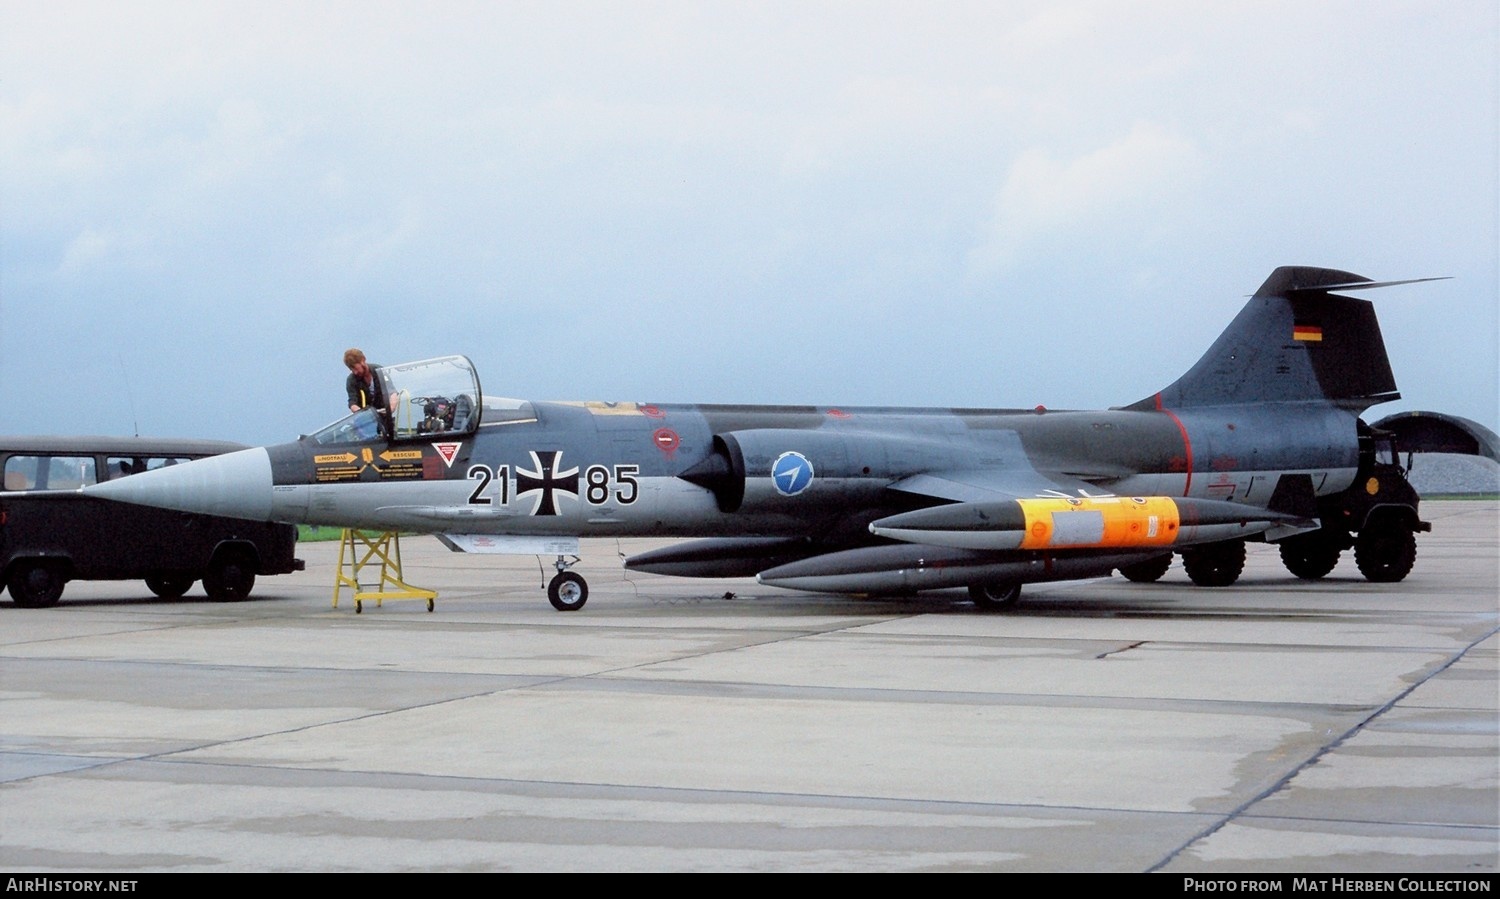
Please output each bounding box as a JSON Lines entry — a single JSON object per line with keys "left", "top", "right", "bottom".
{"left": 0, "top": 501, "right": 1500, "bottom": 875}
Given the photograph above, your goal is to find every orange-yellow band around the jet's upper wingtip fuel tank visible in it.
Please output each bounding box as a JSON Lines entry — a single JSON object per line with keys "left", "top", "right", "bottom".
{"left": 1016, "top": 497, "right": 1182, "bottom": 549}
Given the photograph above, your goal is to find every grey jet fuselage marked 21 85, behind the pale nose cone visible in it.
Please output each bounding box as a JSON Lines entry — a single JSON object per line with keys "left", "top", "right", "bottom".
{"left": 249, "top": 401, "right": 1358, "bottom": 540}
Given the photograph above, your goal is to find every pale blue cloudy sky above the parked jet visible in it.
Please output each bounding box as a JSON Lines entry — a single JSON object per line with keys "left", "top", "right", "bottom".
{"left": 0, "top": 0, "right": 1500, "bottom": 443}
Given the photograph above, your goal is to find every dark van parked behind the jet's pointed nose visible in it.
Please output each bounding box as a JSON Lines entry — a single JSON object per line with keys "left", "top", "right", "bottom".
{"left": 0, "top": 437, "right": 303, "bottom": 608}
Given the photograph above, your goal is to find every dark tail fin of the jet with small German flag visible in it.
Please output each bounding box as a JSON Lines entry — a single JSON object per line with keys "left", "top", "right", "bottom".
{"left": 1127, "top": 266, "right": 1436, "bottom": 413}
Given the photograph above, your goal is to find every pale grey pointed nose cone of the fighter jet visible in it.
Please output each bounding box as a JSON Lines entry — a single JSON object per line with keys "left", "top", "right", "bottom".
{"left": 84, "top": 447, "right": 272, "bottom": 521}
